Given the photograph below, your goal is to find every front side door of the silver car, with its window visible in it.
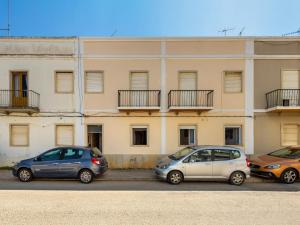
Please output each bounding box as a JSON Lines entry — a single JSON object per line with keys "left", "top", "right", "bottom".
{"left": 184, "top": 150, "right": 212, "bottom": 178}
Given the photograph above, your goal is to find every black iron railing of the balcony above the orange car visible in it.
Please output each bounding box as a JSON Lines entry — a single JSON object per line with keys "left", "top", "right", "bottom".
{"left": 266, "top": 89, "right": 300, "bottom": 109}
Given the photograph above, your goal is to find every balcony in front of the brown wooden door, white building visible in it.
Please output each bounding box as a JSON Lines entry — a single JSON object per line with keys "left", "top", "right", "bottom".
{"left": 0, "top": 90, "right": 40, "bottom": 114}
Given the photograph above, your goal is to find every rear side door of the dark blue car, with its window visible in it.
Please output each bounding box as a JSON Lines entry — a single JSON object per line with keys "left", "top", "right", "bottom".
{"left": 60, "top": 148, "right": 84, "bottom": 177}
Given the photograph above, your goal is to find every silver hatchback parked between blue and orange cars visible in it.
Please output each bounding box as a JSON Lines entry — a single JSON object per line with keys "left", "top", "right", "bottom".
{"left": 155, "top": 146, "right": 250, "bottom": 185}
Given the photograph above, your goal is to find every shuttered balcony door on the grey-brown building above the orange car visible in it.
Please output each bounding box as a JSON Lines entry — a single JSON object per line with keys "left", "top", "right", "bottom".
{"left": 281, "top": 70, "right": 300, "bottom": 106}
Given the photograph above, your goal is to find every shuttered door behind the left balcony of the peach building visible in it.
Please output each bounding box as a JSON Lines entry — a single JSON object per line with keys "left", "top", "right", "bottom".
{"left": 130, "top": 72, "right": 149, "bottom": 107}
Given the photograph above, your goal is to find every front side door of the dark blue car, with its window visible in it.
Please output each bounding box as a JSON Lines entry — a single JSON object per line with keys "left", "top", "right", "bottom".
{"left": 32, "top": 148, "right": 63, "bottom": 177}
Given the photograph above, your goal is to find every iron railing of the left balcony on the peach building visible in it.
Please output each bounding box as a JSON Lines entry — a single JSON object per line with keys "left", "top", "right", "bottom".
{"left": 118, "top": 90, "right": 160, "bottom": 108}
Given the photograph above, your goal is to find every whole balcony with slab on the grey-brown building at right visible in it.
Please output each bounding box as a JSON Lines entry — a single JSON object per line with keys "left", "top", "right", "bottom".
{"left": 266, "top": 89, "right": 300, "bottom": 112}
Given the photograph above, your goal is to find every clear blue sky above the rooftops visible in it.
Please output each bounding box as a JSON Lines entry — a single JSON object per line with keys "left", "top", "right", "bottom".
{"left": 0, "top": 0, "right": 300, "bottom": 37}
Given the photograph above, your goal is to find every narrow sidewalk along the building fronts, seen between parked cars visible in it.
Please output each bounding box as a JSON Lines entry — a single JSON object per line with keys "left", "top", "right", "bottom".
{"left": 0, "top": 169, "right": 274, "bottom": 183}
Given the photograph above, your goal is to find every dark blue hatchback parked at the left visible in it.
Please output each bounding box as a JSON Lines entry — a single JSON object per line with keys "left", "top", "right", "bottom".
{"left": 13, "top": 146, "right": 108, "bottom": 184}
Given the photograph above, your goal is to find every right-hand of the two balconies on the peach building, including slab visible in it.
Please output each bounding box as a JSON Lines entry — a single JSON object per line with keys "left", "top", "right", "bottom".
{"left": 168, "top": 90, "right": 214, "bottom": 112}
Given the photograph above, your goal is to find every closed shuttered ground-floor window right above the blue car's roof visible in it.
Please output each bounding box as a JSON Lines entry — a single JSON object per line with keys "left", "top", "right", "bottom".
{"left": 56, "top": 125, "right": 74, "bottom": 146}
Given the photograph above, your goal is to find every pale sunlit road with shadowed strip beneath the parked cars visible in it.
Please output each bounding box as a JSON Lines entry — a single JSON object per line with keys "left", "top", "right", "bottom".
{"left": 0, "top": 187, "right": 300, "bottom": 225}
